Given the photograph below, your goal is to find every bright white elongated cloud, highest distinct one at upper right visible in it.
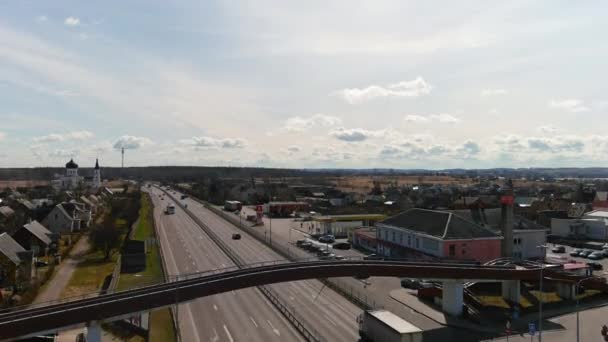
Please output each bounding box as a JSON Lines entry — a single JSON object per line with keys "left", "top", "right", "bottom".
{"left": 335, "top": 77, "right": 433, "bottom": 104}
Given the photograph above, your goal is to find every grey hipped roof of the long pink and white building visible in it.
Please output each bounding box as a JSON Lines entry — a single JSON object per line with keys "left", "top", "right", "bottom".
{"left": 380, "top": 208, "right": 500, "bottom": 240}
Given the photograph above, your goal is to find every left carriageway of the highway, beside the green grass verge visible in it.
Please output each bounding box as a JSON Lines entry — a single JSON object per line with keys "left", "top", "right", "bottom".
{"left": 149, "top": 188, "right": 303, "bottom": 342}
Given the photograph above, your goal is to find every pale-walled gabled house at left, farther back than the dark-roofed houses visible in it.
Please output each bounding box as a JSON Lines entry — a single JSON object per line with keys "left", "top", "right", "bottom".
{"left": 42, "top": 202, "right": 91, "bottom": 234}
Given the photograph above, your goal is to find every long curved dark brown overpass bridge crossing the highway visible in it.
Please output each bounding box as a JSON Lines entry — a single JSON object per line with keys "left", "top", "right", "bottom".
{"left": 0, "top": 260, "right": 605, "bottom": 341}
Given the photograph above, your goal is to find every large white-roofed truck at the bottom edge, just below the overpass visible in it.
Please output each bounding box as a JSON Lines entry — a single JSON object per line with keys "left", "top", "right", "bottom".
{"left": 357, "top": 310, "right": 422, "bottom": 342}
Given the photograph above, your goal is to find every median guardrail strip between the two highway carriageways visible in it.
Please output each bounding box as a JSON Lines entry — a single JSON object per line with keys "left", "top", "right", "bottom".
{"left": 161, "top": 189, "right": 323, "bottom": 342}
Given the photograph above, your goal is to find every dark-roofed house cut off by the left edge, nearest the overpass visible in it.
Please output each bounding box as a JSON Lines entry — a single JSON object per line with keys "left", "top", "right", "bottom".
{"left": 0, "top": 233, "right": 33, "bottom": 287}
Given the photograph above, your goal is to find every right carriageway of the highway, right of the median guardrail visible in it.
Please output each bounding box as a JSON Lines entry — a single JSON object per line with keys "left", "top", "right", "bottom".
{"left": 165, "top": 192, "right": 362, "bottom": 341}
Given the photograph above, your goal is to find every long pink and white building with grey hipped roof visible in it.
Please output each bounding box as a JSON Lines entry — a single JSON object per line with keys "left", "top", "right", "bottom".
{"left": 376, "top": 208, "right": 502, "bottom": 262}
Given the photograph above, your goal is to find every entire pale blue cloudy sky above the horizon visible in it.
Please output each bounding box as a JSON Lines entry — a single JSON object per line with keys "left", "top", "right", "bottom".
{"left": 0, "top": 0, "right": 608, "bottom": 169}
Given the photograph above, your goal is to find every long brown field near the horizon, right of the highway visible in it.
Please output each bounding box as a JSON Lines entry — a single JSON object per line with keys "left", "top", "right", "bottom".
{"left": 327, "top": 176, "right": 472, "bottom": 193}
